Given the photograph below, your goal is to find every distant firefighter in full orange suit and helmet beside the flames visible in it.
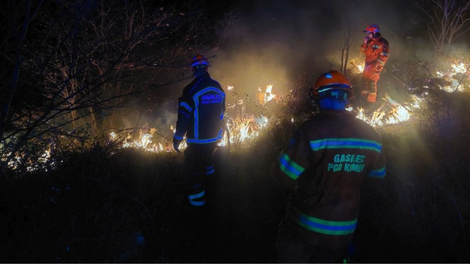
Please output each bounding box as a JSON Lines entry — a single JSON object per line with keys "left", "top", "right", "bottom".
{"left": 361, "top": 24, "right": 390, "bottom": 110}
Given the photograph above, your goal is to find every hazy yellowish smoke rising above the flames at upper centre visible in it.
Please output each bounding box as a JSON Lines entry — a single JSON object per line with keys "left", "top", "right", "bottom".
{"left": 206, "top": 0, "right": 422, "bottom": 92}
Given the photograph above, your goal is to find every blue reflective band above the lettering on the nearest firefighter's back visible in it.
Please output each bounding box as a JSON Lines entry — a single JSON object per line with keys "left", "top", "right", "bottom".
{"left": 310, "top": 138, "right": 382, "bottom": 153}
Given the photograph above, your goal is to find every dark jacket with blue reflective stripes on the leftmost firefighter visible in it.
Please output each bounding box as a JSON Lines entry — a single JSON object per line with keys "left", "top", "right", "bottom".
{"left": 174, "top": 73, "right": 225, "bottom": 144}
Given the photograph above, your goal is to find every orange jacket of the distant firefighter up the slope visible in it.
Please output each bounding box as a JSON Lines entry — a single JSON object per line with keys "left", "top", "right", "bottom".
{"left": 361, "top": 36, "right": 390, "bottom": 80}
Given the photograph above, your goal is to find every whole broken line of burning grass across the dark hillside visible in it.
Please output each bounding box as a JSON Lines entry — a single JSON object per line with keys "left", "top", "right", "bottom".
{"left": 0, "top": 59, "right": 470, "bottom": 173}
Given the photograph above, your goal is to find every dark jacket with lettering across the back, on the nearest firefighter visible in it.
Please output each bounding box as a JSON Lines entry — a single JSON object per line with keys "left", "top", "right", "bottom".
{"left": 280, "top": 111, "right": 385, "bottom": 247}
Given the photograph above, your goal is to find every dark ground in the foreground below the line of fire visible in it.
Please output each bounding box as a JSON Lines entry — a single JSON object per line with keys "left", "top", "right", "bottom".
{"left": 0, "top": 107, "right": 470, "bottom": 262}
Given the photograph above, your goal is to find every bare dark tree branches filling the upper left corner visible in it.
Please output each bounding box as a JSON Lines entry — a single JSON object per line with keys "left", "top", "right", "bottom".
{"left": 0, "top": 0, "right": 214, "bottom": 172}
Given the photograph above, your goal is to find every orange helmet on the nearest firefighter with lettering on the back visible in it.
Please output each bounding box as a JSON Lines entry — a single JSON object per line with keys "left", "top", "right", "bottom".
{"left": 310, "top": 70, "right": 354, "bottom": 102}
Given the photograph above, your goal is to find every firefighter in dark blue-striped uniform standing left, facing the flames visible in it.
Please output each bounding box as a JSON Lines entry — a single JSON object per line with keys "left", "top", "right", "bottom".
{"left": 173, "top": 55, "right": 225, "bottom": 206}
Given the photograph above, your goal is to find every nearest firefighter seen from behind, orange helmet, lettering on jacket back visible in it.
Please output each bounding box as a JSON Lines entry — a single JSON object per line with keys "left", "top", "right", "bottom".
{"left": 277, "top": 70, "right": 385, "bottom": 262}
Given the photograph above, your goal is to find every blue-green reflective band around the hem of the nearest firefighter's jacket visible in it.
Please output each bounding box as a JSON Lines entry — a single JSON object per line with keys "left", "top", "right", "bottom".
{"left": 289, "top": 207, "right": 357, "bottom": 235}
